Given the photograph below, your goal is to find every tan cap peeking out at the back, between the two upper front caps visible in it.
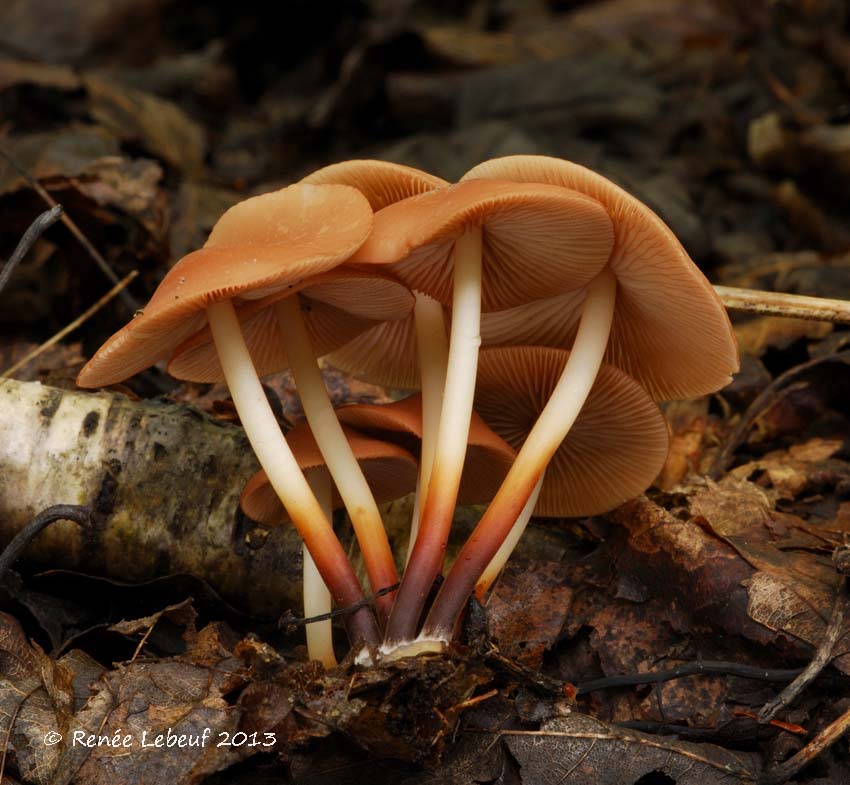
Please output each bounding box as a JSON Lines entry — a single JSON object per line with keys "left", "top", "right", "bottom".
{"left": 301, "top": 158, "right": 448, "bottom": 212}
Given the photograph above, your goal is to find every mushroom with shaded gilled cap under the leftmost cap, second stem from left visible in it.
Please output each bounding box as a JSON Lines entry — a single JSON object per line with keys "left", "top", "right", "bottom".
{"left": 168, "top": 265, "right": 413, "bottom": 619}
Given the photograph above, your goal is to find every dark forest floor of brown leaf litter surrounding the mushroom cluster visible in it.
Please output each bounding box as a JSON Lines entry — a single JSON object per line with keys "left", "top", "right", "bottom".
{"left": 0, "top": 0, "right": 850, "bottom": 785}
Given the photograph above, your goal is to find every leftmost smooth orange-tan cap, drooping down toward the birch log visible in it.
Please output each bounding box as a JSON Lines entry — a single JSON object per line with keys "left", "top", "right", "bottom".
{"left": 77, "top": 185, "right": 372, "bottom": 387}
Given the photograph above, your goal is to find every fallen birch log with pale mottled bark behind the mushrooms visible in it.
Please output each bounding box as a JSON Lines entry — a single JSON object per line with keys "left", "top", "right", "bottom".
{"left": 0, "top": 380, "right": 567, "bottom": 617}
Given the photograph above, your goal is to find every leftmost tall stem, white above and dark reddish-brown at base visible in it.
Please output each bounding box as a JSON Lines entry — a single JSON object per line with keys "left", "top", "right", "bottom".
{"left": 207, "top": 300, "right": 380, "bottom": 646}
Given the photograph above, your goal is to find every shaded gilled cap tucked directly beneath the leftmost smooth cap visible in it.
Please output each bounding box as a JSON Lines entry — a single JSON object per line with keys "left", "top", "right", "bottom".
{"left": 168, "top": 265, "right": 413, "bottom": 382}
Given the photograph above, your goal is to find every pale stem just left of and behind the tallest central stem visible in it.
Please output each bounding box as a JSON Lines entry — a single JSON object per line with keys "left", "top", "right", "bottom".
{"left": 405, "top": 292, "right": 449, "bottom": 564}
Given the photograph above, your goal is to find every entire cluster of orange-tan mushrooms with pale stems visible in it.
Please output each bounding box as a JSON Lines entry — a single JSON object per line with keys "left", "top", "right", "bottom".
{"left": 78, "top": 156, "right": 738, "bottom": 667}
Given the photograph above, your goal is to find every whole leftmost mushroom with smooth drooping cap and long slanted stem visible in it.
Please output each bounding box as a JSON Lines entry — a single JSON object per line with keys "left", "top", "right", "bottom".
{"left": 77, "top": 185, "right": 379, "bottom": 645}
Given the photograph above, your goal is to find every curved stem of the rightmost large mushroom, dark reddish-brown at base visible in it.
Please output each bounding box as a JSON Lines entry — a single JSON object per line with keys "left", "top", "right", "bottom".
{"left": 422, "top": 269, "right": 617, "bottom": 640}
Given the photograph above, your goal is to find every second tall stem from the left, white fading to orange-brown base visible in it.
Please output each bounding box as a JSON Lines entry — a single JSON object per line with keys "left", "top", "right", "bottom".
{"left": 277, "top": 295, "right": 398, "bottom": 621}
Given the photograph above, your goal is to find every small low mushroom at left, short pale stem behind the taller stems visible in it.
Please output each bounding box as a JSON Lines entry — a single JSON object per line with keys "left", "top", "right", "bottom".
{"left": 240, "top": 422, "right": 417, "bottom": 668}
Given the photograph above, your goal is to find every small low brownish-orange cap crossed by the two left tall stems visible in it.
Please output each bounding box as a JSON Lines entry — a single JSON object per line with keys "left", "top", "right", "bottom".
{"left": 240, "top": 421, "right": 418, "bottom": 526}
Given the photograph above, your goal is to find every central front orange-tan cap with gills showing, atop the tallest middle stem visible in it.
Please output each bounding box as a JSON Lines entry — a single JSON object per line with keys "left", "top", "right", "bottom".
{"left": 352, "top": 179, "right": 614, "bottom": 311}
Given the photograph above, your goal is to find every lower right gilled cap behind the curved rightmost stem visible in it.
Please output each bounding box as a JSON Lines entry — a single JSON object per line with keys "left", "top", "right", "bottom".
{"left": 475, "top": 346, "right": 669, "bottom": 517}
